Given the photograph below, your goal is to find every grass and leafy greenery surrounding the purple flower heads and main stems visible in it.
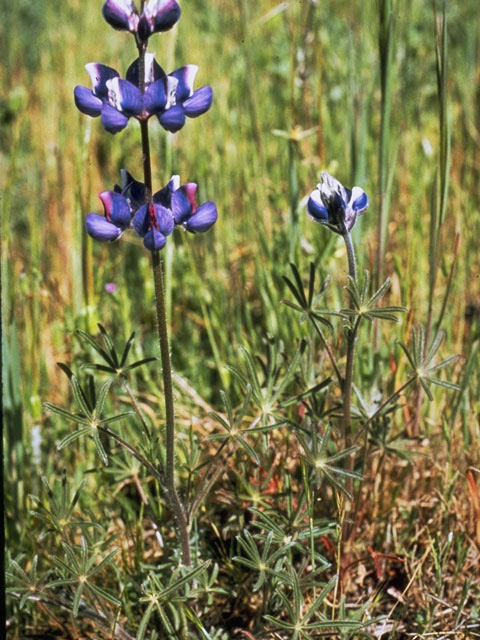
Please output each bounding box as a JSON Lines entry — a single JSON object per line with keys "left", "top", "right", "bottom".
{"left": 4, "top": 0, "right": 480, "bottom": 640}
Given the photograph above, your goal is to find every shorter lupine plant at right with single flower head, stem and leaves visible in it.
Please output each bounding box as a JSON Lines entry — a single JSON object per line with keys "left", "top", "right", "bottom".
{"left": 285, "top": 171, "right": 459, "bottom": 559}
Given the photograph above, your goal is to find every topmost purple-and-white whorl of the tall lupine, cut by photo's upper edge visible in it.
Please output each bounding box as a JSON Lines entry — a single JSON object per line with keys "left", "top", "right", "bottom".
{"left": 102, "top": 0, "right": 181, "bottom": 42}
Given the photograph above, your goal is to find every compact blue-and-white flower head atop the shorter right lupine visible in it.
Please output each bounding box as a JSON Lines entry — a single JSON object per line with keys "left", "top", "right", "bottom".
{"left": 307, "top": 171, "right": 369, "bottom": 235}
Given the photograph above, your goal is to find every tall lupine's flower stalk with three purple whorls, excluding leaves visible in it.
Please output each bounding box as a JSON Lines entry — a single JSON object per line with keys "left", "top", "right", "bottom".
{"left": 74, "top": 0, "right": 217, "bottom": 566}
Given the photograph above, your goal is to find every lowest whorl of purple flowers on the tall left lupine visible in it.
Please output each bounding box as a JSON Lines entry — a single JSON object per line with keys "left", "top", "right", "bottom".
{"left": 86, "top": 170, "right": 218, "bottom": 251}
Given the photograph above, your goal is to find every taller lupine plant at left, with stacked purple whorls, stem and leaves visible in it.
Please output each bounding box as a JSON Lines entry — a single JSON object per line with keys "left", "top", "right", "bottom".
{"left": 9, "top": 0, "right": 217, "bottom": 638}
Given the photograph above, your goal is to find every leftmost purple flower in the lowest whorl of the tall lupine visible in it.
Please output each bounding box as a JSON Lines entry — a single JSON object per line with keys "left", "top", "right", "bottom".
{"left": 85, "top": 191, "right": 132, "bottom": 242}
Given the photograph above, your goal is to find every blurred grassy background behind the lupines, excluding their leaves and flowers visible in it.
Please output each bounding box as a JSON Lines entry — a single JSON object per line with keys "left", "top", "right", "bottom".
{"left": 0, "top": 0, "right": 480, "bottom": 638}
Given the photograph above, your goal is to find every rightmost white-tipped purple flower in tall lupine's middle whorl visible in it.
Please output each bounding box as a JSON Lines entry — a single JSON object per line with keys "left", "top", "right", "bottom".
{"left": 157, "top": 64, "right": 213, "bottom": 133}
